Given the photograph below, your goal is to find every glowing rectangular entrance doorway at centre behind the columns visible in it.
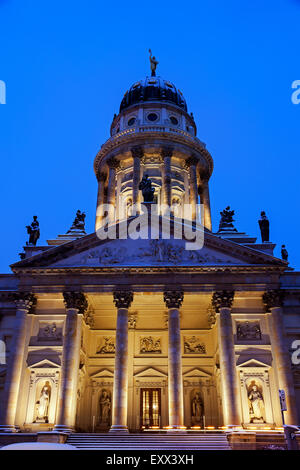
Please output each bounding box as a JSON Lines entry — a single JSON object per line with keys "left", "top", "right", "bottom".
{"left": 140, "top": 388, "right": 161, "bottom": 428}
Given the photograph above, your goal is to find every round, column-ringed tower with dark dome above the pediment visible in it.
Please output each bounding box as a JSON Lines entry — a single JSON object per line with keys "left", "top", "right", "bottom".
{"left": 94, "top": 70, "right": 213, "bottom": 230}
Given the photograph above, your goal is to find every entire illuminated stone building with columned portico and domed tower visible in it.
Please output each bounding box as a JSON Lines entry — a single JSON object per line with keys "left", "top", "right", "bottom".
{"left": 0, "top": 68, "right": 300, "bottom": 433}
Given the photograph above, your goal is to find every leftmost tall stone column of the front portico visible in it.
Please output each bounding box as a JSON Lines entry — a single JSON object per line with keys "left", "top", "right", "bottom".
{"left": 0, "top": 292, "right": 36, "bottom": 432}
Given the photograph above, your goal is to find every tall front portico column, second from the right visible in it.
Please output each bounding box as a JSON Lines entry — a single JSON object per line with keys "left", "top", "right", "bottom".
{"left": 212, "top": 290, "right": 241, "bottom": 427}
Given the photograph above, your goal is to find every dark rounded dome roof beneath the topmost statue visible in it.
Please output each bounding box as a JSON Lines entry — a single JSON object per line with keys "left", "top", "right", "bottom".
{"left": 120, "top": 77, "right": 187, "bottom": 112}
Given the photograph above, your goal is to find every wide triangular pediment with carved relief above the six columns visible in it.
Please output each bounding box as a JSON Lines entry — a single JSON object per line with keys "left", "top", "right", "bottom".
{"left": 11, "top": 219, "right": 287, "bottom": 272}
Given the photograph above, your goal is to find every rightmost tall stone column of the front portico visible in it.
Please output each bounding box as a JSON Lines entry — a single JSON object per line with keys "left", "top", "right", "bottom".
{"left": 263, "top": 289, "right": 299, "bottom": 425}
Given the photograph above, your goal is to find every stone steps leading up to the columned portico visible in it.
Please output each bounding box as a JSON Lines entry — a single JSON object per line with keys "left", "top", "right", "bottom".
{"left": 66, "top": 432, "right": 230, "bottom": 451}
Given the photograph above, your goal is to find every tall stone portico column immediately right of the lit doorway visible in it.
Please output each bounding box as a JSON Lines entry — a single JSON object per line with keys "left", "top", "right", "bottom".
{"left": 164, "top": 291, "right": 184, "bottom": 431}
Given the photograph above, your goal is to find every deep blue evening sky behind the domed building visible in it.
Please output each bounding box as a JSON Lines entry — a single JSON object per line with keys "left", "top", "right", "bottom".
{"left": 0, "top": 0, "right": 300, "bottom": 272}
